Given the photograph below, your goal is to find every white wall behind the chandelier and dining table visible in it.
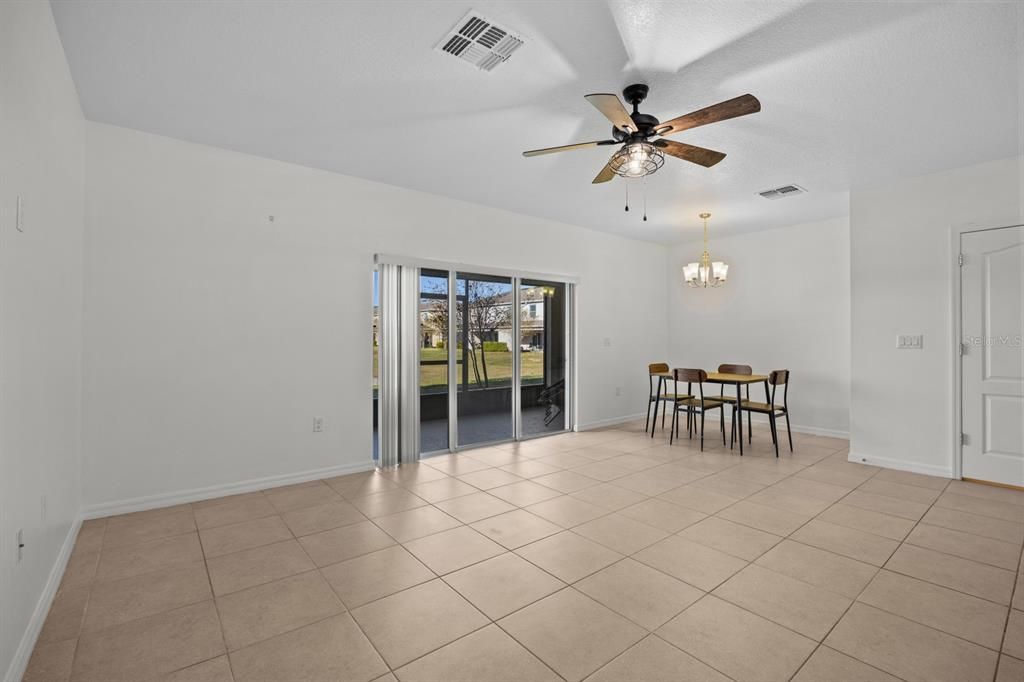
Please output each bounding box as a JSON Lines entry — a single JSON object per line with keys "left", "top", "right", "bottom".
{"left": 667, "top": 215, "right": 850, "bottom": 437}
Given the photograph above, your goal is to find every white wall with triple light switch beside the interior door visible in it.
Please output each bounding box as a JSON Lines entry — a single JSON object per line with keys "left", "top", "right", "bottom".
{"left": 850, "top": 158, "right": 1024, "bottom": 476}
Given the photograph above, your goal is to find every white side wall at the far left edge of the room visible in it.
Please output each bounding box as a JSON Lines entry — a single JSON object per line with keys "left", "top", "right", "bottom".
{"left": 0, "top": 2, "right": 83, "bottom": 679}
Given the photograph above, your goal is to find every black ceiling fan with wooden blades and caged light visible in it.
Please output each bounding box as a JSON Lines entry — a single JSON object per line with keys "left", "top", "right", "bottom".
{"left": 522, "top": 83, "right": 761, "bottom": 183}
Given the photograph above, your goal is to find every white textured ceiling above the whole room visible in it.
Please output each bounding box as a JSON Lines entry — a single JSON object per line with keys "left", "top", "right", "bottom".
{"left": 52, "top": 0, "right": 1024, "bottom": 248}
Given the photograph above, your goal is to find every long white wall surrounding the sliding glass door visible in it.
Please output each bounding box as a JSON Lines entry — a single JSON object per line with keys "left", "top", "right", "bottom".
{"left": 84, "top": 123, "right": 668, "bottom": 512}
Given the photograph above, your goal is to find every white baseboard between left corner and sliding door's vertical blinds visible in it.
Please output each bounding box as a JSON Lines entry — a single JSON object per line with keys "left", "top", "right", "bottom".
{"left": 82, "top": 460, "right": 375, "bottom": 518}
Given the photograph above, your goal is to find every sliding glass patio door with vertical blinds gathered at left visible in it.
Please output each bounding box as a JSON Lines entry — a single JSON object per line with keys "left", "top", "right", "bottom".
{"left": 373, "top": 254, "right": 573, "bottom": 466}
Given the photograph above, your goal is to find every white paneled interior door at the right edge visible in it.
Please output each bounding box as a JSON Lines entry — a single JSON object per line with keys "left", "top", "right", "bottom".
{"left": 961, "top": 226, "right": 1024, "bottom": 486}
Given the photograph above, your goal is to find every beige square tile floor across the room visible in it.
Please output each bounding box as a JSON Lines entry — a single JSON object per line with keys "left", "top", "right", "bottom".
{"left": 25, "top": 424, "right": 1024, "bottom": 682}
